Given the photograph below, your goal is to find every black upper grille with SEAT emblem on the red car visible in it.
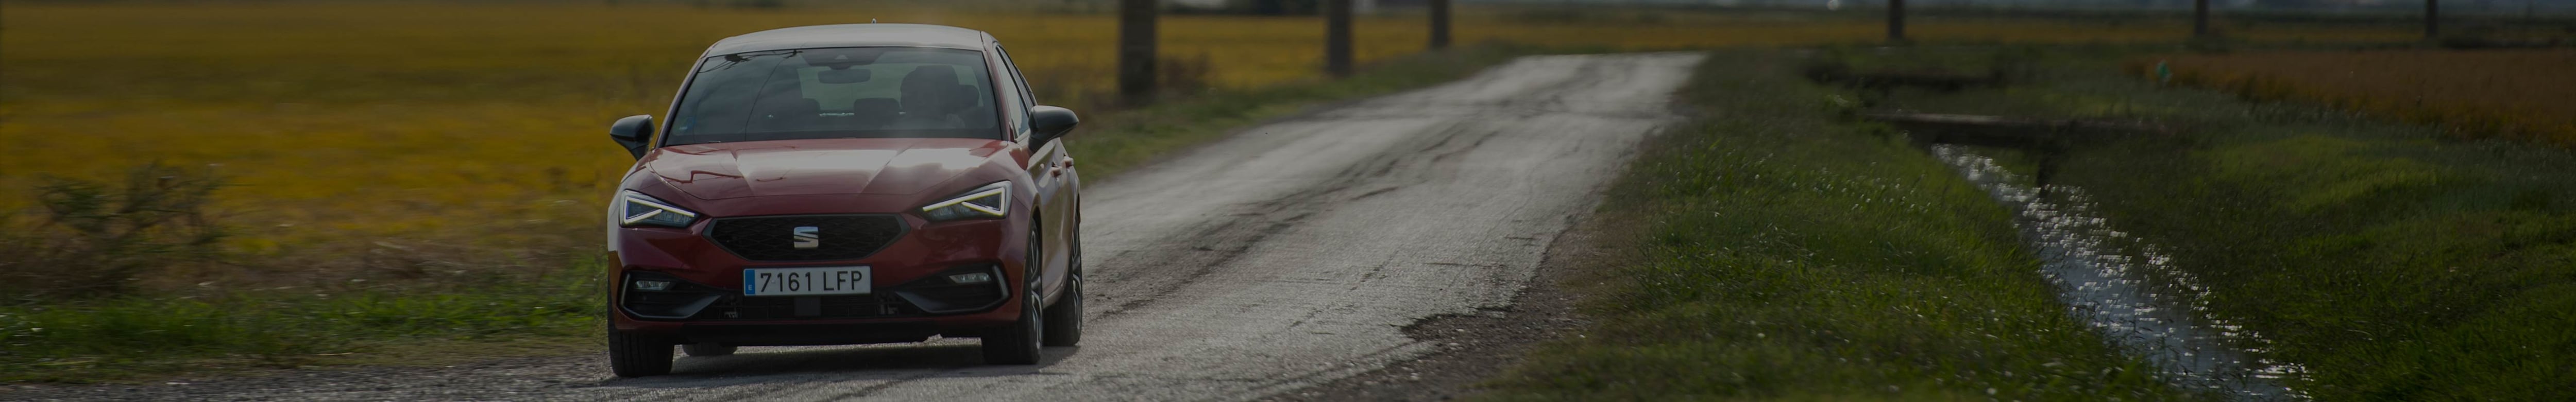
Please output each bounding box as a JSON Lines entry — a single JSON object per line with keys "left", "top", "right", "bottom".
{"left": 706, "top": 214, "right": 904, "bottom": 260}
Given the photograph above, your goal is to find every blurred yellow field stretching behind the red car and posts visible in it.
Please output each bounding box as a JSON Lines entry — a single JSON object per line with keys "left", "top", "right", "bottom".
{"left": 0, "top": 3, "right": 2409, "bottom": 273}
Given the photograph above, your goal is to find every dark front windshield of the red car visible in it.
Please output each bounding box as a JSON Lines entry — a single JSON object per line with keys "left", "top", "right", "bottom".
{"left": 665, "top": 46, "right": 1002, "bottom": 144}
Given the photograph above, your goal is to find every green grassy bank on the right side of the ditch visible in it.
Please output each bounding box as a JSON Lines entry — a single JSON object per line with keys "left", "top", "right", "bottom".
{"left": 1855, "top": 49, "right": 2576, "bottom": 399}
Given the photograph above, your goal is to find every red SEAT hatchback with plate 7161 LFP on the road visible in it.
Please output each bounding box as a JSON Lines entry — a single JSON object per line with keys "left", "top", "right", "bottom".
{"left": 608, "top": 23, "right": 1082, "bottom": 376}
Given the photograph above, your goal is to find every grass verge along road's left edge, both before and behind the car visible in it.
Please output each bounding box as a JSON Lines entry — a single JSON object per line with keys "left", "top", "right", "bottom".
{"left": 0, "top": 46, "right": 1540, "bottom": 384}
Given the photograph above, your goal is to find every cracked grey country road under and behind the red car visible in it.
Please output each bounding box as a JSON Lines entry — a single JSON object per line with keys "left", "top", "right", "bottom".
{"left": 30, "top": 54, "right": 1700, "bottom": 399}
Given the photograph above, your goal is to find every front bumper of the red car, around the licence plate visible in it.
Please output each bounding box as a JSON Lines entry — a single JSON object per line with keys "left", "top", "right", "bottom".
{"left": 608, "top": 217, "right": 1028, "bottom": 345}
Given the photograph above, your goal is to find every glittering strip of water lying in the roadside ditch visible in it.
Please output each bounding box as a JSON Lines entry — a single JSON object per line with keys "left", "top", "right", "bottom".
{"left": 1932, "top": 144, "right": 2306, "bottom": 402}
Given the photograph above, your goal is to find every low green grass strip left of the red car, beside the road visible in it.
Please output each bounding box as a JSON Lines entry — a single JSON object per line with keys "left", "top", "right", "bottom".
{"left": 0, "top": 266, "right": 603, "bottom": 381}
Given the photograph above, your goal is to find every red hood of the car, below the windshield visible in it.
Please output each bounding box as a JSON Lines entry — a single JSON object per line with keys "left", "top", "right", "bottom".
{"left": 641, "top": 139, "right": 1007, "bottom": 198}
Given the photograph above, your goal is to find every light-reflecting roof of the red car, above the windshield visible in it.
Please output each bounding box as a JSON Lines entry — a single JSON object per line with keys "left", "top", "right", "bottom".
{"left": 701, "top": 23, "right": 992, "bottom": 57}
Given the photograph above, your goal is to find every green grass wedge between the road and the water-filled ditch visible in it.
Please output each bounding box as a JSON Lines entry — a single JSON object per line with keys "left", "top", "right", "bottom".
{"left": 1484, "top": 51, "right": 2195, "bottom": 399}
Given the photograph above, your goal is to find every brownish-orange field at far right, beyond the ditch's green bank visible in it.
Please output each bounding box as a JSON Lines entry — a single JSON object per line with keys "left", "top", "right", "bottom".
{"left": 2133, "top": 49, "right": 2576, "bottom": 147}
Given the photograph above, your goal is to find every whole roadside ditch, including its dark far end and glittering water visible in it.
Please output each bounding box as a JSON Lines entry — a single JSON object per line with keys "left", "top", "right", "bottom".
{"left": 1806, "top": 49, "right": 2306, "bottom": 399}
